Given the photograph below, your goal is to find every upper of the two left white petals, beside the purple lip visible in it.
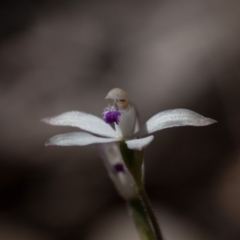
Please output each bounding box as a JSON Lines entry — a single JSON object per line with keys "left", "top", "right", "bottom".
{"left": 42, "top": 111, "right": 118, "bottom": 137}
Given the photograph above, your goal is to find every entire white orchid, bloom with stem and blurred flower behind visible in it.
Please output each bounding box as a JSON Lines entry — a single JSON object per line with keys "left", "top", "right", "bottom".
{"left": 42, "top": 88, "right": 216, "bottom": 240}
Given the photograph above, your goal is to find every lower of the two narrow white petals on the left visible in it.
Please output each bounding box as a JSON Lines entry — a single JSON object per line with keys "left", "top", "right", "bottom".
{"left": 45, "top": 132, "right": 119, "bottom": 146}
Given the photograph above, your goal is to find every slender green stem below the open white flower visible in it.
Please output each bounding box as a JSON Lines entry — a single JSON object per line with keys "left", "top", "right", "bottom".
{"left": 120, "top": 141, "right": 163, "bottom": 240}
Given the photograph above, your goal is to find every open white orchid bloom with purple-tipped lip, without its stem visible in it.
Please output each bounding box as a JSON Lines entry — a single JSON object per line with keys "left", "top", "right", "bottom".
{"left": 42, "top": 88, "right": 216, "bottom": 150}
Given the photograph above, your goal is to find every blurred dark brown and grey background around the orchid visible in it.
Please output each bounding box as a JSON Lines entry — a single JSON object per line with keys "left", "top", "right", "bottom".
{"left": 0, "top": 0, "right": 240, "bottom": 240}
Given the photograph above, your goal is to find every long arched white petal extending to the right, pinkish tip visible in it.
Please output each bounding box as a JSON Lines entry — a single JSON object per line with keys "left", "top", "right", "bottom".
{"left": 136, "top": 109, "right": 216, "bottom": 136}
